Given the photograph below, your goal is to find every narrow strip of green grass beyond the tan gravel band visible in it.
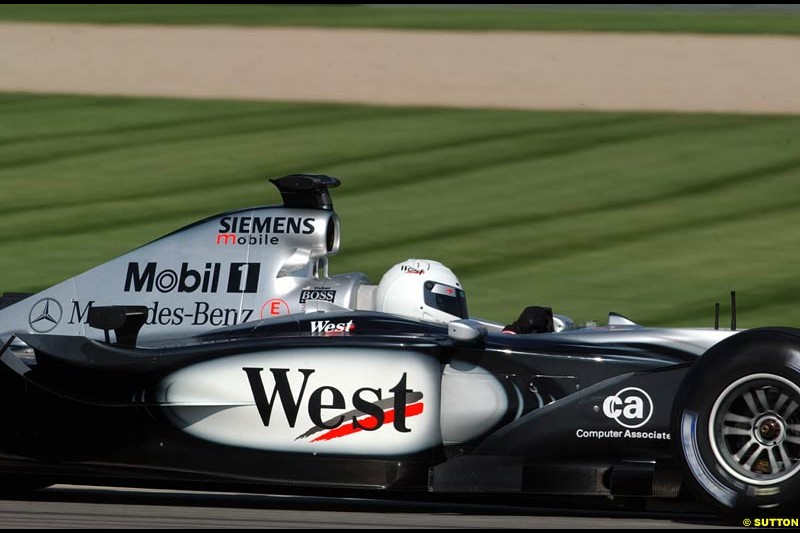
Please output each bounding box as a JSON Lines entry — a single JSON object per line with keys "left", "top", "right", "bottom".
{"left": 0, "top": 4, "right": 800, "bottom": 35}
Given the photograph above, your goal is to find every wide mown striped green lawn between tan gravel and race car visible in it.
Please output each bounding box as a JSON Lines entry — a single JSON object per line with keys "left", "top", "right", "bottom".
{"left": 0, "top": 94, "right": 800, "bottom": 326}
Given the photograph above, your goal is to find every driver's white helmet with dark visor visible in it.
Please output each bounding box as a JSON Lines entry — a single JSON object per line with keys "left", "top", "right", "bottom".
{"left": 375, "top": 259, "right": 469, "bottom": 323}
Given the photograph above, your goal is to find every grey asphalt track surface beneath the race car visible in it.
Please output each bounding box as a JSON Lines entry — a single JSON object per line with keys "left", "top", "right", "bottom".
{"left": 0, "top": 485, "right": 724, "bottom": 529}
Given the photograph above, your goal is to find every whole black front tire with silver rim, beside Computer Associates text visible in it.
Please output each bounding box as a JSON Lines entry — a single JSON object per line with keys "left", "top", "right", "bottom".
{"left": 672, "top": 328, "right": 800, "bottom": 517}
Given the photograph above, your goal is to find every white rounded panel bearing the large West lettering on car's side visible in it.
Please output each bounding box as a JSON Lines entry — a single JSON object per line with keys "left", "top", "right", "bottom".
{"left": 156, "top": 347, "right": 441, "bottom": 457}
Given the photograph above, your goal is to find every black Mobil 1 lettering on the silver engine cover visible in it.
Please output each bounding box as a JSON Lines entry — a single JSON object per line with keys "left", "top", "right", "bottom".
{"left": 124, "top": 261, "right": 261, "bottom": 293}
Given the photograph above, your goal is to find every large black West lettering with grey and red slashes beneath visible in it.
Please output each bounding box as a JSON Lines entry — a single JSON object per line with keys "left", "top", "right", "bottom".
{"left": 242, "top": 367, "right": 423, "bottom": 442}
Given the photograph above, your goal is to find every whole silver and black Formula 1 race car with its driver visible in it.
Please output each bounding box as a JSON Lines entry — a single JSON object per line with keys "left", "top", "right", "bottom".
{"left": 0, "top": 175, "right": 800, "bottom": 512}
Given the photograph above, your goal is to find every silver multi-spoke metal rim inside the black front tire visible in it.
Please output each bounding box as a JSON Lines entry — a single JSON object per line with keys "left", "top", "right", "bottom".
{"left": 708, "top": 374, "right": 800, "bottom": 485}
